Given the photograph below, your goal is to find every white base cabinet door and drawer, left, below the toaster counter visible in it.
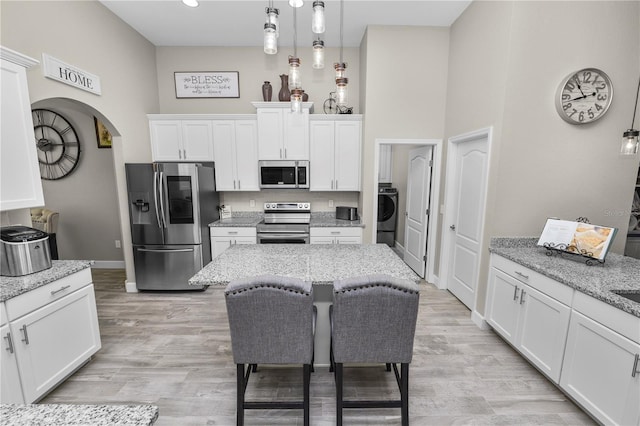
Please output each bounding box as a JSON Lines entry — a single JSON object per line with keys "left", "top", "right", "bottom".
{"left": 5, "top": 268, "right": 101, "bottom": 403}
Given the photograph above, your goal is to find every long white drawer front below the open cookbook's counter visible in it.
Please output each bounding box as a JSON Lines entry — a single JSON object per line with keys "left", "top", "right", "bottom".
{"left": 491, "top": 254, "right": 573, "bottom": 306}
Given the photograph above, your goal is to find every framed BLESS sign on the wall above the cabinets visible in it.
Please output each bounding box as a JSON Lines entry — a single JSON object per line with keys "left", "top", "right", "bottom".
{"left": 173, "top": 71, "right": 240, "bottom": 99}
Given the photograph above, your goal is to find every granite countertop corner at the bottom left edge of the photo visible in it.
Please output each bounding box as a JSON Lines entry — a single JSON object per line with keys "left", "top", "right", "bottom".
{"left": 0, "top": 404, "right": 158, "bottom": 426}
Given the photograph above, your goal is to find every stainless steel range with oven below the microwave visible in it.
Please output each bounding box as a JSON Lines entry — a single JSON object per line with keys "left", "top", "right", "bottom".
{"left": 257, "top": 202, "right": 311, "bottom": 244}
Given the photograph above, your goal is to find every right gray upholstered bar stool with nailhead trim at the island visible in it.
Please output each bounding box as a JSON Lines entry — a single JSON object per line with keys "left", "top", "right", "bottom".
{"left": 330, "top": 275, "right": 420, "bottom": 426}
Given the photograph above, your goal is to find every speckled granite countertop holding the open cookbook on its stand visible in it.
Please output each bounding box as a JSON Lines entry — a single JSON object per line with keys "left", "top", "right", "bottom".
{"left": 489, "top": 237, "right": 640, "bottom": 317}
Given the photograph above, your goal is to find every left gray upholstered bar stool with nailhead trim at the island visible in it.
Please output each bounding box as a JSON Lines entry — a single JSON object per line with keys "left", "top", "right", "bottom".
{"left": 225, "top": 275, "right": 316, "bottom": 425}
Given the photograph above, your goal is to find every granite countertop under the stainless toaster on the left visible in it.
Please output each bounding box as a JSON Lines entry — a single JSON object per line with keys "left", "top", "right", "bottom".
{"left": 0, "top": 260, "right": 93, "bottom": 302}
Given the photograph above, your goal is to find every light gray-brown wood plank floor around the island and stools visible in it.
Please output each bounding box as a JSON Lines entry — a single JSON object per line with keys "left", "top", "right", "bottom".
{"left": 41, "top": 270, "right": 594, "bottom": 426}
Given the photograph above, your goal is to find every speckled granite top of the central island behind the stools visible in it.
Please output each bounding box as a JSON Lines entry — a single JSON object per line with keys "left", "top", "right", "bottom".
{"left": 189, "top": 244, "right": 420, "bottom": 286}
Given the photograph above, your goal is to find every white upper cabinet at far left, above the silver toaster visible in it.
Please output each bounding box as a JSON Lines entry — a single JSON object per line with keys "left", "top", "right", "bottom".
{"left": 0, "top": 46, "right": 44, "bottom": 211}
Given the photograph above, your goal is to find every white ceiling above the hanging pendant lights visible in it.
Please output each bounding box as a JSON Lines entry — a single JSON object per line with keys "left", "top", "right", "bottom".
{"left": 100, "top": 0, "right": 471, "bottom": 47}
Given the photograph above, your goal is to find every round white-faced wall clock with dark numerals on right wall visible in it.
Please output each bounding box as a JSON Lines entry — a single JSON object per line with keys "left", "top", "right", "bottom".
{"left": 556, "top": 68, "right": 613, "bottom": 124}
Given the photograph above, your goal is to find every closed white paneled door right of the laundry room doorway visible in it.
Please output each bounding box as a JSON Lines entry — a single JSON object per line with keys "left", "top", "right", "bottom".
{"left": 445, "top": 133, "right": 489, "bottom": 309}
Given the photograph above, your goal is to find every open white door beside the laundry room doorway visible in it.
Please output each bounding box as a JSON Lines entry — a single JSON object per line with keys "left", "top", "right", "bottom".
{"left": 404, "top": 146, "right": 433, "bottom": 278}
